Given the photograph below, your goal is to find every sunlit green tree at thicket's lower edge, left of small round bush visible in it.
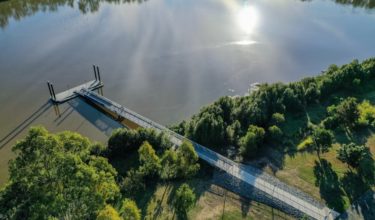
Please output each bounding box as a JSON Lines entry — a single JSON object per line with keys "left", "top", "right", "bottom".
{"left": 240, "top": 125, "right": 265, "bottom": 156}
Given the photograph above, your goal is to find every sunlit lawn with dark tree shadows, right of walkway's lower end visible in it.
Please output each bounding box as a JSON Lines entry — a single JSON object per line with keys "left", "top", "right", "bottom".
{"left": 268, "top": 135, "right": 375, "bottom": 211}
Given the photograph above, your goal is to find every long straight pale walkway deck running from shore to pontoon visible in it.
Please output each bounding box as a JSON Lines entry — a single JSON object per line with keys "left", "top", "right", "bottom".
{"left": 76, "top": 89, "right": 339, "bottom": 219}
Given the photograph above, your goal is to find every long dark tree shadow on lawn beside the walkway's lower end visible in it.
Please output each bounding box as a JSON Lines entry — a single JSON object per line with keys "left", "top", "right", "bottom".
{"left": 314, "top": 159, "right": 344, "bottom": 212}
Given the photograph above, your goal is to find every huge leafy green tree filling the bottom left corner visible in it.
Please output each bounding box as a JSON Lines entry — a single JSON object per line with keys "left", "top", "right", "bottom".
{"left": 0, "top": 127, "right": 119, "bottom": 219}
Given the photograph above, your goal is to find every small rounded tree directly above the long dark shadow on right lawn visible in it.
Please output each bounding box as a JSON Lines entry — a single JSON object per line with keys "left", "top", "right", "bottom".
{"left": 312, "top": 127, "right": 333, "bottom": 157}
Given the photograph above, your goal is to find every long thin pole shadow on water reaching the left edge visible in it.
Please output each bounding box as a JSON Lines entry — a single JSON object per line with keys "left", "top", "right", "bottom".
{"left": 0, "top": 101, "right": 52, "bottom": 149}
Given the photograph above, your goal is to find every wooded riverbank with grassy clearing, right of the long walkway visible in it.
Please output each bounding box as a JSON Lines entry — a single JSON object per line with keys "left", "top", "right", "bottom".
{"left": 171, "top": 58, "right": 375, "bottom": 212}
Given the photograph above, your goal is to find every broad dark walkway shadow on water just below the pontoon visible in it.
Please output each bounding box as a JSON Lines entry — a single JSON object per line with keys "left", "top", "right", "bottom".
{"left": 66, "top": 98, "right": 124, "bottom": 136}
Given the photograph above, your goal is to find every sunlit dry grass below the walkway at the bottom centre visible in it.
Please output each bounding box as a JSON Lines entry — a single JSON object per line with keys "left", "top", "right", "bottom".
{"left": 141, "top": 178, "right": 292, "bottom": 220}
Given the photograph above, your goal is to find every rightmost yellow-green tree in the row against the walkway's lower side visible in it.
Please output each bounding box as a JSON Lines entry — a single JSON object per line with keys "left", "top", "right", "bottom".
{"left": 177, "top": 141, "right": 199, "bottom": 178}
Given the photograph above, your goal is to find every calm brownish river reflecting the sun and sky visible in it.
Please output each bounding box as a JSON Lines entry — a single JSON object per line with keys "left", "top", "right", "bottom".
{"left": 0, "top": 0, "right": 375, "bottom": 184}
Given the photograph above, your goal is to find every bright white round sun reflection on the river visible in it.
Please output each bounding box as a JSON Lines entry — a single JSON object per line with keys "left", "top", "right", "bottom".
{"left": 237, "top": 5, "right": 258, "bottom": 34}
